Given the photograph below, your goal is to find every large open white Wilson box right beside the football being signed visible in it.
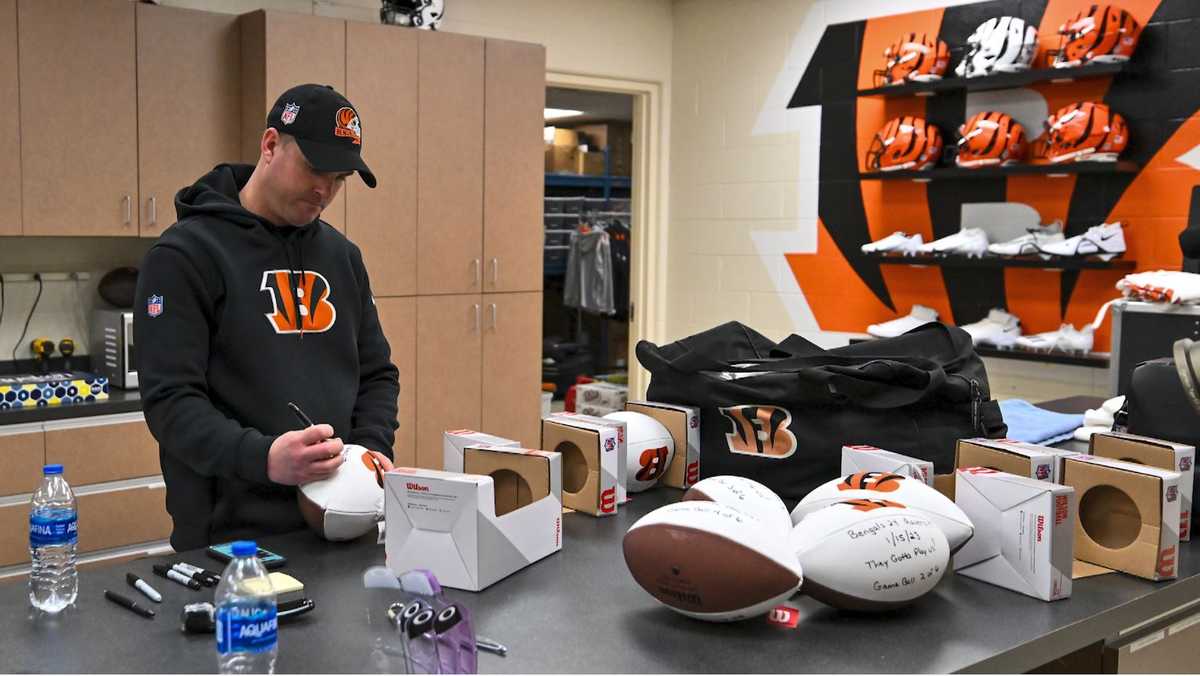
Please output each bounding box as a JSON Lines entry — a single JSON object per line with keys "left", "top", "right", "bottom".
{"left": 384, "top": 447, "right": 563, "bottom": 592}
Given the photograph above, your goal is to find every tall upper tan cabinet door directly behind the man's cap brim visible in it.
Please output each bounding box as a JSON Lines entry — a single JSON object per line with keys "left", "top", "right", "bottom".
{"left": 344, "top": 22, "right": 418, "bottom": 297}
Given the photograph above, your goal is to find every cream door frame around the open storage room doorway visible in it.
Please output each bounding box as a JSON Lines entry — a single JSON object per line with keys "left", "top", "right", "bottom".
{"left": 546, "top": 71, "right": 668, "bottom": 399}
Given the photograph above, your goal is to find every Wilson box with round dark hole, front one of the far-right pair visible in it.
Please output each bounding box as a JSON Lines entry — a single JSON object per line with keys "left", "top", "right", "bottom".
{"left": 1062, "top": 455, "right": 1180, "bottom": 580}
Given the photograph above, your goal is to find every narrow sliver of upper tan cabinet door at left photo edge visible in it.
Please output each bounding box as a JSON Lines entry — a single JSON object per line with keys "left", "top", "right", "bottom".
{"left": 0, "top": 0, "right": 22, "bottom": 235}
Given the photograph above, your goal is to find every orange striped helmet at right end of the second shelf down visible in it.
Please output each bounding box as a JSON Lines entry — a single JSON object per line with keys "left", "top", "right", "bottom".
{"left": 1046, "top": 101, "right": 1129, "bottom": 163}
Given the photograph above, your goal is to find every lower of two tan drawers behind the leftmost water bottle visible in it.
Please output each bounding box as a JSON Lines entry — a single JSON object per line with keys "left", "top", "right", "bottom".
{"left": 0, "top": 481, "right": 172, "bottom": 567}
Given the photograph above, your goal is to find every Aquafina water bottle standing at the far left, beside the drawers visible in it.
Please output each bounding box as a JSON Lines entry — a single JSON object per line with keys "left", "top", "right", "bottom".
{"left": 29, "top": 465, "right": 79, "bottom": 614}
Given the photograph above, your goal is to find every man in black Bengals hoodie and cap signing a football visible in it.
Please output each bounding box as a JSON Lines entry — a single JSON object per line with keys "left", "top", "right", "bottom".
{"left": 134, "top": 84, "right": 400, "bottom": 551}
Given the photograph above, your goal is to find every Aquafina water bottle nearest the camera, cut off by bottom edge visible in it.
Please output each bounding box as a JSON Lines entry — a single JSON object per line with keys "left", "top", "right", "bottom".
{"left": 214, "top": 540, "right": 278, "bottom": 674}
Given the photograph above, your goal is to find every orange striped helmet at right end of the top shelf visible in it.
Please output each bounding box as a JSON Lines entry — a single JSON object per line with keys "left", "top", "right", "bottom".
{"left": 1049, "top": 5, "right": 1141, "bottom": 68}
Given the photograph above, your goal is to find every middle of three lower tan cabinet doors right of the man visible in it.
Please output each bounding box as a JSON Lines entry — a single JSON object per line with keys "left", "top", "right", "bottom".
{"left": 416, "top": 294, "right": 484, "bottom": 469}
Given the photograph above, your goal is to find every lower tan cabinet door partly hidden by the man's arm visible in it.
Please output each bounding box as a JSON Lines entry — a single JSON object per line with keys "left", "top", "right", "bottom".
{"left": 376, "top": 297, "right": 416, "bottom": 467}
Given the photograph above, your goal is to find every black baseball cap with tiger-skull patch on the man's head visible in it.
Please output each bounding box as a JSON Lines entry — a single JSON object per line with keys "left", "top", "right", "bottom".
{"left": 266, "top": 84, "right": 376, "bottom": 187}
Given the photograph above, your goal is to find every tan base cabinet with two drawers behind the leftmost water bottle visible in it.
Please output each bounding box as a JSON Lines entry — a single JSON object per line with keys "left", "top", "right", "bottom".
{"left": 0, "top": 413, "right": 172, "bottom": 580}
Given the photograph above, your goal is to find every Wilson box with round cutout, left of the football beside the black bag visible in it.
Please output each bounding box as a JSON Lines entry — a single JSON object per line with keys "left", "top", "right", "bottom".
{"left": 541, "top": 415, "right": 622, "bottom": 516}
